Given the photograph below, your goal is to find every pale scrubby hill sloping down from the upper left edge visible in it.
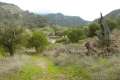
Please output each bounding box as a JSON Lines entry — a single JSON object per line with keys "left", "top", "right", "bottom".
{"left": 0, "top": 2, "right": 47, "bottom": 27}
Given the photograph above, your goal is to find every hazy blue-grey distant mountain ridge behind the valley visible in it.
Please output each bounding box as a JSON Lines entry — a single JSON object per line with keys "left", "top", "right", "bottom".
{"left": 44, "top": 13, "right": 89, "bottom": 26}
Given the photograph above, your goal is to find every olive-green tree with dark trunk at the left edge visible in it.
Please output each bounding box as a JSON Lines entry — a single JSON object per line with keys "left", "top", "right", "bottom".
{"left": 0, "top": 24, "right": 23, "bottom": 56}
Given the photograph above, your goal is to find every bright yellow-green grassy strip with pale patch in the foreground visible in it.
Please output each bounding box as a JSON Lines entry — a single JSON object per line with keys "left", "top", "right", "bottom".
{"left": 0, "top": 56, "right": 91, "bottom": 80}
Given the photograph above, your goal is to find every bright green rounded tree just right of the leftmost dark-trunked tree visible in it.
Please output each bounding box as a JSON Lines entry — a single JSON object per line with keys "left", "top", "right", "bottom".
{"left": 28, "top": 31, "right": 48, "bottom": 52}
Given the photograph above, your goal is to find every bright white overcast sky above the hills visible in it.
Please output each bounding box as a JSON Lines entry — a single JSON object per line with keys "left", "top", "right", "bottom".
{"left": 0, "top": 0, "right": 120, "bottom": 21}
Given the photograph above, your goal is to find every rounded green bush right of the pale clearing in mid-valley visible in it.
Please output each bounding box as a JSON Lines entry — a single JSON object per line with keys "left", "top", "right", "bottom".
{"left": 67, "top": 29, "right": 86, "bottom": 43}
